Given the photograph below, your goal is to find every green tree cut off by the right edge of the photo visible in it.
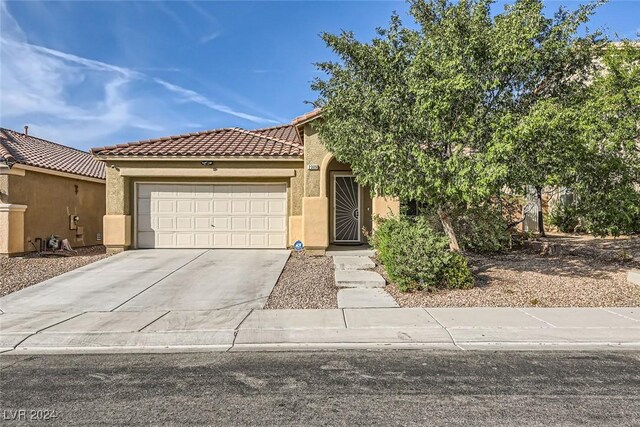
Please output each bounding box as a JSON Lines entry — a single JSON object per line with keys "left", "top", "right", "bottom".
{"left": 567, "top": 42, "right": 640, "bottom": 236}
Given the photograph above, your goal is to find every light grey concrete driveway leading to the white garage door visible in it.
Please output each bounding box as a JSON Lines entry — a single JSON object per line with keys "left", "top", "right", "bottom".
{"left": 0, "top": 249, "right": 289, "bottom": 313}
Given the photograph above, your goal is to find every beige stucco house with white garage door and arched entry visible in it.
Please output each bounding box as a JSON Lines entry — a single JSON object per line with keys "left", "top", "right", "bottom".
{"left": 91, "top": 111, "right": 399, "bottom": 252}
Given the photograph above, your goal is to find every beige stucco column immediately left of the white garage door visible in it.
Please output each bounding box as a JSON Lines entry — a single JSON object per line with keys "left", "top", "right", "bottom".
{"left": 103, "top": 165, "right": 132, "bottom": 253}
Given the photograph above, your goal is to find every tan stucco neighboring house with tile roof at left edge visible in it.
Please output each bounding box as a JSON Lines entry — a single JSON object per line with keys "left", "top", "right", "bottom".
{"left": 0, "top": 127, "right": 105, "bottom": 256}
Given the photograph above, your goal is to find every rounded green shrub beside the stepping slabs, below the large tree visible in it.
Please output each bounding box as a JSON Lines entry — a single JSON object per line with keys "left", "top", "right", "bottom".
{"left": 370, "top": 217, "right": 473, "bottom": 292}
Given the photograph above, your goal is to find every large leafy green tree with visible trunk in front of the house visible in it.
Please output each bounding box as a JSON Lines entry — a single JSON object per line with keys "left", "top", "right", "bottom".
{"left": 313, "top": 0, "right": 603, "bottom": 250}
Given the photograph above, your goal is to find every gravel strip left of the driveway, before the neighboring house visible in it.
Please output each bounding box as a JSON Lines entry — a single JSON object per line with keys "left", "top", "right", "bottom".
{"left": 0, "top": 246, "right": 109, "bottom": 296}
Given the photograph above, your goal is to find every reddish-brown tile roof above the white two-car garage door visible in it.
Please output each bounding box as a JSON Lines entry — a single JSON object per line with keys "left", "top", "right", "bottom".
{"left": 91, "top": 125, "right": 303, "bottom": 157}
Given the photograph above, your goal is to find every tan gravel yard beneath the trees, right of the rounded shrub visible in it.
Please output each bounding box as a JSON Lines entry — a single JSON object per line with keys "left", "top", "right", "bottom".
{"left": 376, "top": 236, "right": 640, "bottom": 307}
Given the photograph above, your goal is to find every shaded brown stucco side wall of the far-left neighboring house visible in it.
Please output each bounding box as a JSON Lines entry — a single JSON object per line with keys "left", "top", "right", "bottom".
{"left": 6, "top": 170, "right": 105, "bottom": 252}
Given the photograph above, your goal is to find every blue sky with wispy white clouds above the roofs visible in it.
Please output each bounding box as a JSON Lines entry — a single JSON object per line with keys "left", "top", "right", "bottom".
{"left": 0, "top": 0, "right": 640, "bottom": 149}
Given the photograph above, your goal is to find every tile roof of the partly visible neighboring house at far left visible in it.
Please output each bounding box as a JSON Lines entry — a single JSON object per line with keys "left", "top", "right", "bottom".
{"left": 0, "top": 128, "right": 105, "bottom": 179}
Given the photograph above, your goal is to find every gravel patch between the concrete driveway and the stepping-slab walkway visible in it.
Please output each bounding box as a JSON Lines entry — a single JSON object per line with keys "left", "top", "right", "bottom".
{"left": 264, "top": 252, "right": 338, "bottom": 309}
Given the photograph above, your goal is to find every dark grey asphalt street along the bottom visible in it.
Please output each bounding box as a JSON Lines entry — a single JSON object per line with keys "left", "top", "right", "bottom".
{"left": 0, "top": 350, "right": 640, "bottom": 426}
